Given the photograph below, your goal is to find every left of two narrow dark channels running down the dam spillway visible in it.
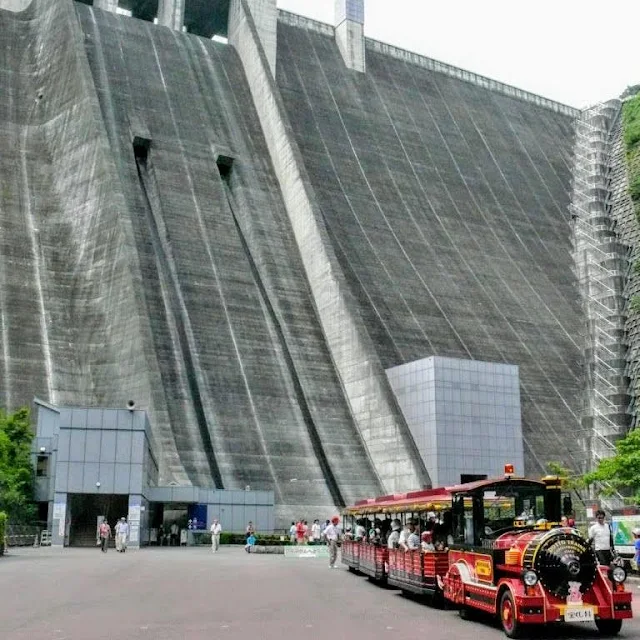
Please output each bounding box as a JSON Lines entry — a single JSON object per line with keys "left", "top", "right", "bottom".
{"left": 132, "top": 136, "right": 224, "bottom": 489}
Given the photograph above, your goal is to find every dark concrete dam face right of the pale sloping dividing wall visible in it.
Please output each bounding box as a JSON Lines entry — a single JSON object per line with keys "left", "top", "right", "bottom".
{"left": 278, "top": 23, "right": 584, "bottom": 472}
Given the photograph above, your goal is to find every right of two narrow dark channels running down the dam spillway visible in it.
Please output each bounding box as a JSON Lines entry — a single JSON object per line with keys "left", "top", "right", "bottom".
{"left": 216, "top": 154, "right": 345, "bottom": 507}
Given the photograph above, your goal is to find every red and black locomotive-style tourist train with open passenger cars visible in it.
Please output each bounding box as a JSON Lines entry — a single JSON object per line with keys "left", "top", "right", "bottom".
{"left": 342, "top": 465, "right": 632, "bottom": 638}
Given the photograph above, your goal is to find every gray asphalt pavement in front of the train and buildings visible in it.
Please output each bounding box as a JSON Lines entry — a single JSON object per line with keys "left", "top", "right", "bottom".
{"left": 0, "top": 547, "right": 640, "bottom": 640}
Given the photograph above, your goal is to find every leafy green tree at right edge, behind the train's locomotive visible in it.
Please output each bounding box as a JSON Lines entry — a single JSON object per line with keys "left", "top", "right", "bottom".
{"left": 584, "top": 429, "right": 640, "bottom": 502}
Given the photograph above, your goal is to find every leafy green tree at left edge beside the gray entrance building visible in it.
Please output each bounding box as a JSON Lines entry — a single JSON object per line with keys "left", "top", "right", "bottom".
{"left": 0, "top": 407, "right": 35, "bottom": 522}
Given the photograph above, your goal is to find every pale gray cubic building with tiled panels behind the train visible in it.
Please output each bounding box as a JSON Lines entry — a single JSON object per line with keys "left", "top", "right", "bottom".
{"left": 386, "top": 356, "right": 524, "bottom": 486}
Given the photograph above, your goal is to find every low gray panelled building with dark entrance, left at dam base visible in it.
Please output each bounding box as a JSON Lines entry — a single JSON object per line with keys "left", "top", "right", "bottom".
{"left": 33, "top": 400, "right": 274, "bottom": 548}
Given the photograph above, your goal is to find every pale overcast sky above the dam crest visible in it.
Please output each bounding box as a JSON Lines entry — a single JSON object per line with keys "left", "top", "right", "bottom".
{"left": 278, "top": 0, "right": 640, "bottom": 107}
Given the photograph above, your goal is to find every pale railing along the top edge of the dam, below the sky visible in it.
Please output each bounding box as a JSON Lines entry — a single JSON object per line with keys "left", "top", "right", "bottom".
{"left": 278, "top": 9, "right": 581, "bottom": 118}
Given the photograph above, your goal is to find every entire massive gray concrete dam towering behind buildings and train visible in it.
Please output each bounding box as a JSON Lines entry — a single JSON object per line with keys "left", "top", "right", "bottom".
{"left": 0, "top": 0, "right": 639, "bottom": 526}
